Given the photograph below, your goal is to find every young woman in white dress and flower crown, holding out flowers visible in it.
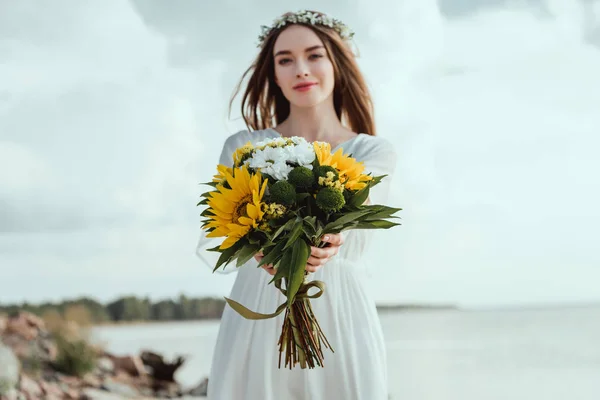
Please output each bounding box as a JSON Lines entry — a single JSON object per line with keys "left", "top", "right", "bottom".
{"left": 197, "top": 11, "right": 396, "bottom": 400}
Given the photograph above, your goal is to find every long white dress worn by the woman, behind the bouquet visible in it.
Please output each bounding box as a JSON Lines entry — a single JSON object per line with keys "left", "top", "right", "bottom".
{"left": 196, "top": 129, "right": 396, "bottom": 400}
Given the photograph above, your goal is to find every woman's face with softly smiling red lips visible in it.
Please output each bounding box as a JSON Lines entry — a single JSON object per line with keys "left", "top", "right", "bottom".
{"left": 273, "top": 25, "right": 335, "bottom": 107}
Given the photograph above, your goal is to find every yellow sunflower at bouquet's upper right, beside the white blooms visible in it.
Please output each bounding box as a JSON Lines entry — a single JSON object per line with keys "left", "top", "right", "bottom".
{"left": 313, "top": 142, "right": 373, "bottom": 190}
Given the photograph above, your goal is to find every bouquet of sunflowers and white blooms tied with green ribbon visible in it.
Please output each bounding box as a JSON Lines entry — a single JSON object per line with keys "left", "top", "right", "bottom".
{"left": 198, "top": 137, "right": 401, "bottom": 369}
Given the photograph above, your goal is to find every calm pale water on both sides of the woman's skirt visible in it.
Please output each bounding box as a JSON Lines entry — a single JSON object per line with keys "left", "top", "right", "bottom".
{"left": 93, "top": 307, "right": 600, "bottom": 400}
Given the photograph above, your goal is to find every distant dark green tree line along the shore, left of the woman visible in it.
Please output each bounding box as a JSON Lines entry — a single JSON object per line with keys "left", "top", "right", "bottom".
{"left": 0, "top": 295, "right": 225, "bottom": 324}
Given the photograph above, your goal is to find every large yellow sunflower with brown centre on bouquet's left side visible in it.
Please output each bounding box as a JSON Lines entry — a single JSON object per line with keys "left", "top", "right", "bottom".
{"left": 206, "top": 166, "right": 267, "bottom": 250}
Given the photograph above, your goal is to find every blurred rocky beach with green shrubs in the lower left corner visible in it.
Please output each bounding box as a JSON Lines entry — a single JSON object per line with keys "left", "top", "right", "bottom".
{"left": 0, "top": 312, "right": 208, "bottom": 400}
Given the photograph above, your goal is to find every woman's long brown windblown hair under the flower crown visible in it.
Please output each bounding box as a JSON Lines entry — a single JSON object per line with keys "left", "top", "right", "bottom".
{"left": 229, "top": 11, "right": 376, "bottom": 135}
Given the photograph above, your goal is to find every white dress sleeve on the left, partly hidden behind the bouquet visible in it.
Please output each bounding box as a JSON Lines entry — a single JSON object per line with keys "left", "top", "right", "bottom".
{"left": 196, "top": 131, "right": 244, "bottom": 274}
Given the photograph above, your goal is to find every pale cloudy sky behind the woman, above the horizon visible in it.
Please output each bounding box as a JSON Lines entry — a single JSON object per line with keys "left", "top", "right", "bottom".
{"left": 0, "top": 0, "right": 600, "bottom": 307}
